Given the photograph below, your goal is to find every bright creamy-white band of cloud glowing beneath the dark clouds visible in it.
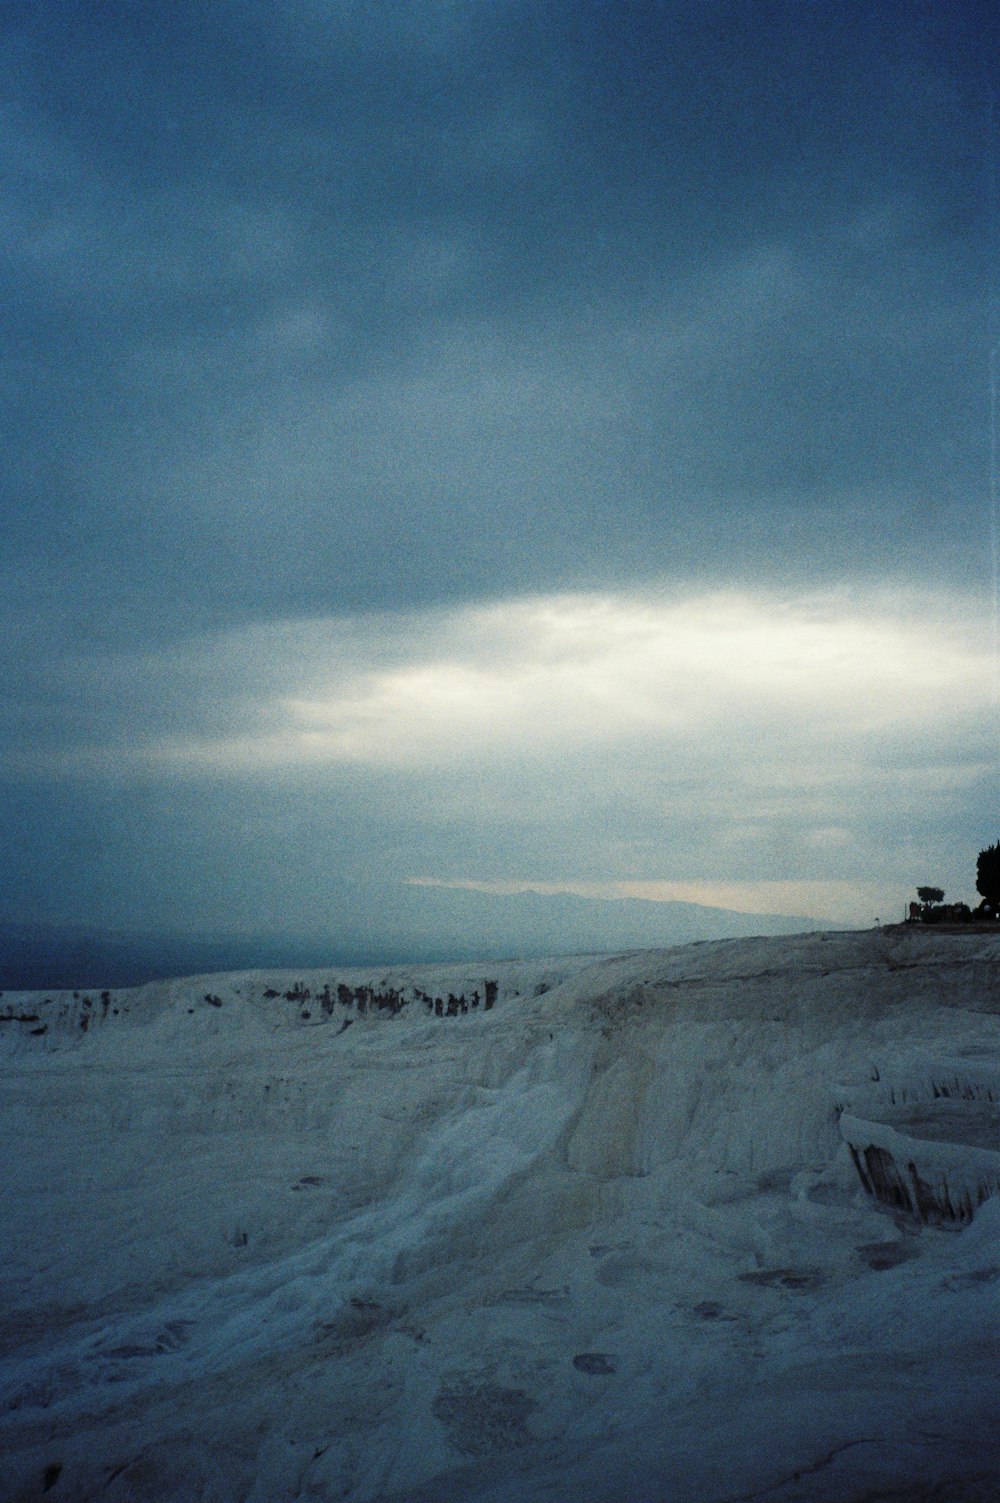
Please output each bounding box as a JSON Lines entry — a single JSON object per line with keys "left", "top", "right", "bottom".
{"left": 138, "top": 594, "right": 991, "bottom": 780}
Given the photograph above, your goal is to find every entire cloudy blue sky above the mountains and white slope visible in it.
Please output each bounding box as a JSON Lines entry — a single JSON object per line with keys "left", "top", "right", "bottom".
{"left": 0, "top": 0, "right": 1000, "bottom": 935}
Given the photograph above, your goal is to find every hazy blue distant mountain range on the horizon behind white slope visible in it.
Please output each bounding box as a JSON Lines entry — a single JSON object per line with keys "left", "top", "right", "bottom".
{"left": 0, "top": 884, "right": 842, "bottom": 990}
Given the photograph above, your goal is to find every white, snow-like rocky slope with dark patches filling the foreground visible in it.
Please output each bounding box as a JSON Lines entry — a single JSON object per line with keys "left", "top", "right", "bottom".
{"left": 0, "top": 929, "right": 1000, "bottom": 1503}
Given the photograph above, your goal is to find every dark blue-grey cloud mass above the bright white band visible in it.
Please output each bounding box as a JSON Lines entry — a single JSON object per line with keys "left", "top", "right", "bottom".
{"left": 5, "top": 3, "right": 988, "bottom": 634}
